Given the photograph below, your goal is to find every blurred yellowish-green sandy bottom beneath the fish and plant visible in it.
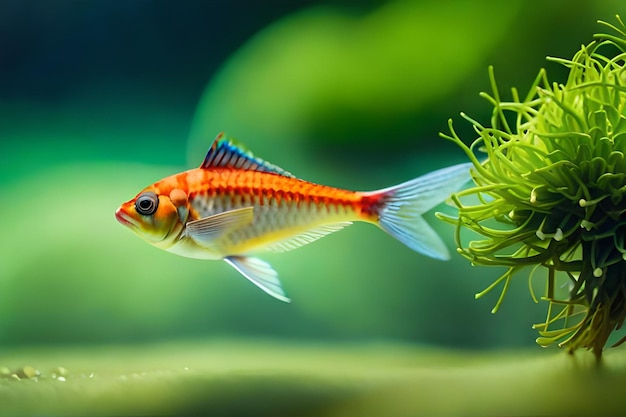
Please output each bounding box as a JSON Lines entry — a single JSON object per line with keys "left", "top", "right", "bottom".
{"left": 0, "top": 341, "right": 626, "bottom": 416}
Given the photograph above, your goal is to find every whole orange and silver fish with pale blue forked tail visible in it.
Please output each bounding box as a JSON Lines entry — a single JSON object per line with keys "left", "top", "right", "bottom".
{"left": 115, "top": 133, "right": 472, "bottom": 302}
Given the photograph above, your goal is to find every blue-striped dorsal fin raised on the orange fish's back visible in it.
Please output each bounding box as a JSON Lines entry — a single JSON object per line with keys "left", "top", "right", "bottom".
{"left": 200, "top": 133, "right": 295, "bottom": 178}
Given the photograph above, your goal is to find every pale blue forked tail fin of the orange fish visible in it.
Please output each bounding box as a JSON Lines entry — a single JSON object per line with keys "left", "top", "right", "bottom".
{"left": 363, "top": 163, "right": 472, "bottom": 260}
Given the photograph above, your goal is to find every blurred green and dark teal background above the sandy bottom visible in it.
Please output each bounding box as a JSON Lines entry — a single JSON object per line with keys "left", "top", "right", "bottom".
{"left": 0, "top": 0, "right": 625, "bottom": 349}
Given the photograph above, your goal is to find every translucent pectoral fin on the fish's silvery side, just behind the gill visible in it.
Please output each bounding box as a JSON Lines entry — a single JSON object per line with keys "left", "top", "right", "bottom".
{"left": 185, "top": 207, "right": 254, "bottom": 246}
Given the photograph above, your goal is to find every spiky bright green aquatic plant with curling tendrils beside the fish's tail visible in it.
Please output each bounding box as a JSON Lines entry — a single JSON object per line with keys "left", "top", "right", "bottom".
{"left": 440, "top": 16, "right": 626, "bottom": 358}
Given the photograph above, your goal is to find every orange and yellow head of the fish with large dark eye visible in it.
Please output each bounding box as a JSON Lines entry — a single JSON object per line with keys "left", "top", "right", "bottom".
{"left": 115, "top": 187, "right": 188, "bottom": 249}
